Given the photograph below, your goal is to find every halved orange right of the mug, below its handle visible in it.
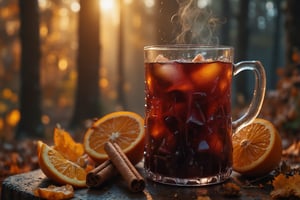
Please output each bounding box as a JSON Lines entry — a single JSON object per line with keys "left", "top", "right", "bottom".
{"left": 232, "top": 118, "right": 282, "bottom": 176}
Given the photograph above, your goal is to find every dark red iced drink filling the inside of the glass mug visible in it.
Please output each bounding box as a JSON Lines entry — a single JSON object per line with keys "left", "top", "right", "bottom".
{"left": 145, "top": 55, "right": 232, "bottom": 178}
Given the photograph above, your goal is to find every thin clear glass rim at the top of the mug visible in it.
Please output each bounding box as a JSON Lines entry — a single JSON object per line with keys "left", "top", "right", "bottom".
{"left": 144, "top": 44, "right": 234, "bottom": 50}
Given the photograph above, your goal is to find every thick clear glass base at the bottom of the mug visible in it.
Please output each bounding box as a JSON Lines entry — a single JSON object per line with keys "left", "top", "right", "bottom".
{"left": 145, "top": 168, "right": 232, "bottom": 186}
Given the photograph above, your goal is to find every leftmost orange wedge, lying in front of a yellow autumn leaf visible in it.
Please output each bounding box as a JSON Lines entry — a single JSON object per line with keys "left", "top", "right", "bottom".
{"left": 38, "top": 141, "right": 86, "bottom": 187}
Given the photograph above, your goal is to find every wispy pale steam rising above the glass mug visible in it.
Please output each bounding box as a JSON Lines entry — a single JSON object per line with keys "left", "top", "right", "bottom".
{"left": 172, "top": 0, "right": 220, "bottom": 45}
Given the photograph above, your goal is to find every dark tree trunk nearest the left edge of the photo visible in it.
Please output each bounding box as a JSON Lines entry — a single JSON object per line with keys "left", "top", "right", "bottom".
{"left": 16, "top": 0, "right": 44, "bottom": 139}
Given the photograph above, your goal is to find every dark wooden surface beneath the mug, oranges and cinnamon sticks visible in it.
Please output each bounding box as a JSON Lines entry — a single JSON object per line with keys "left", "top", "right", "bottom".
{"left": 1, "top": 163, "right": 272, "bottom": 200}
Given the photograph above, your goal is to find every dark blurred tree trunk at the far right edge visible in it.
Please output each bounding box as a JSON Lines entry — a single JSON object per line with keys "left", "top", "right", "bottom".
{"left": 285, "top": 0, "right": 300, "bottom": 66}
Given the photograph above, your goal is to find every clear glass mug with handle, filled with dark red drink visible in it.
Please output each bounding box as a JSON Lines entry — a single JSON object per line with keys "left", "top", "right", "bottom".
{"left": 144, "top": 45, "right": 266, "bottom": 186}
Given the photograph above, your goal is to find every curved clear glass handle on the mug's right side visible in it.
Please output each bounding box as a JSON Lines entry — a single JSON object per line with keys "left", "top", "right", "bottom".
{"left": 232, "top": 61, "right": 266, "bottom": 133}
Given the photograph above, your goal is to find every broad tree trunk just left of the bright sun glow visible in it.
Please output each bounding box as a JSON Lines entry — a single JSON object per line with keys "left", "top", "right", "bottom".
{"left": 71, "top": 0, "right": 100, "bottom": 127}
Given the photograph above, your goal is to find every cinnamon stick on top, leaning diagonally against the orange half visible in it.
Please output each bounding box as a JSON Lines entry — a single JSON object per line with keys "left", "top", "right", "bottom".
{"left": 104, "top": 142, "right": 145, "bottom": 192}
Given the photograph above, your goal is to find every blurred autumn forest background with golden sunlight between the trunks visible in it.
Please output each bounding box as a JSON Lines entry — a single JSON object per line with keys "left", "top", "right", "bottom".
{"left": 0, "top": 0, "right": 300, "bottom": 141}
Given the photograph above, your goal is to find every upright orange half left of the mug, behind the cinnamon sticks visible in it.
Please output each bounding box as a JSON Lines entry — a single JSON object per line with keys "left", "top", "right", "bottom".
{"left": 83, "top": 111, "right": 145, "bottom": 164}
